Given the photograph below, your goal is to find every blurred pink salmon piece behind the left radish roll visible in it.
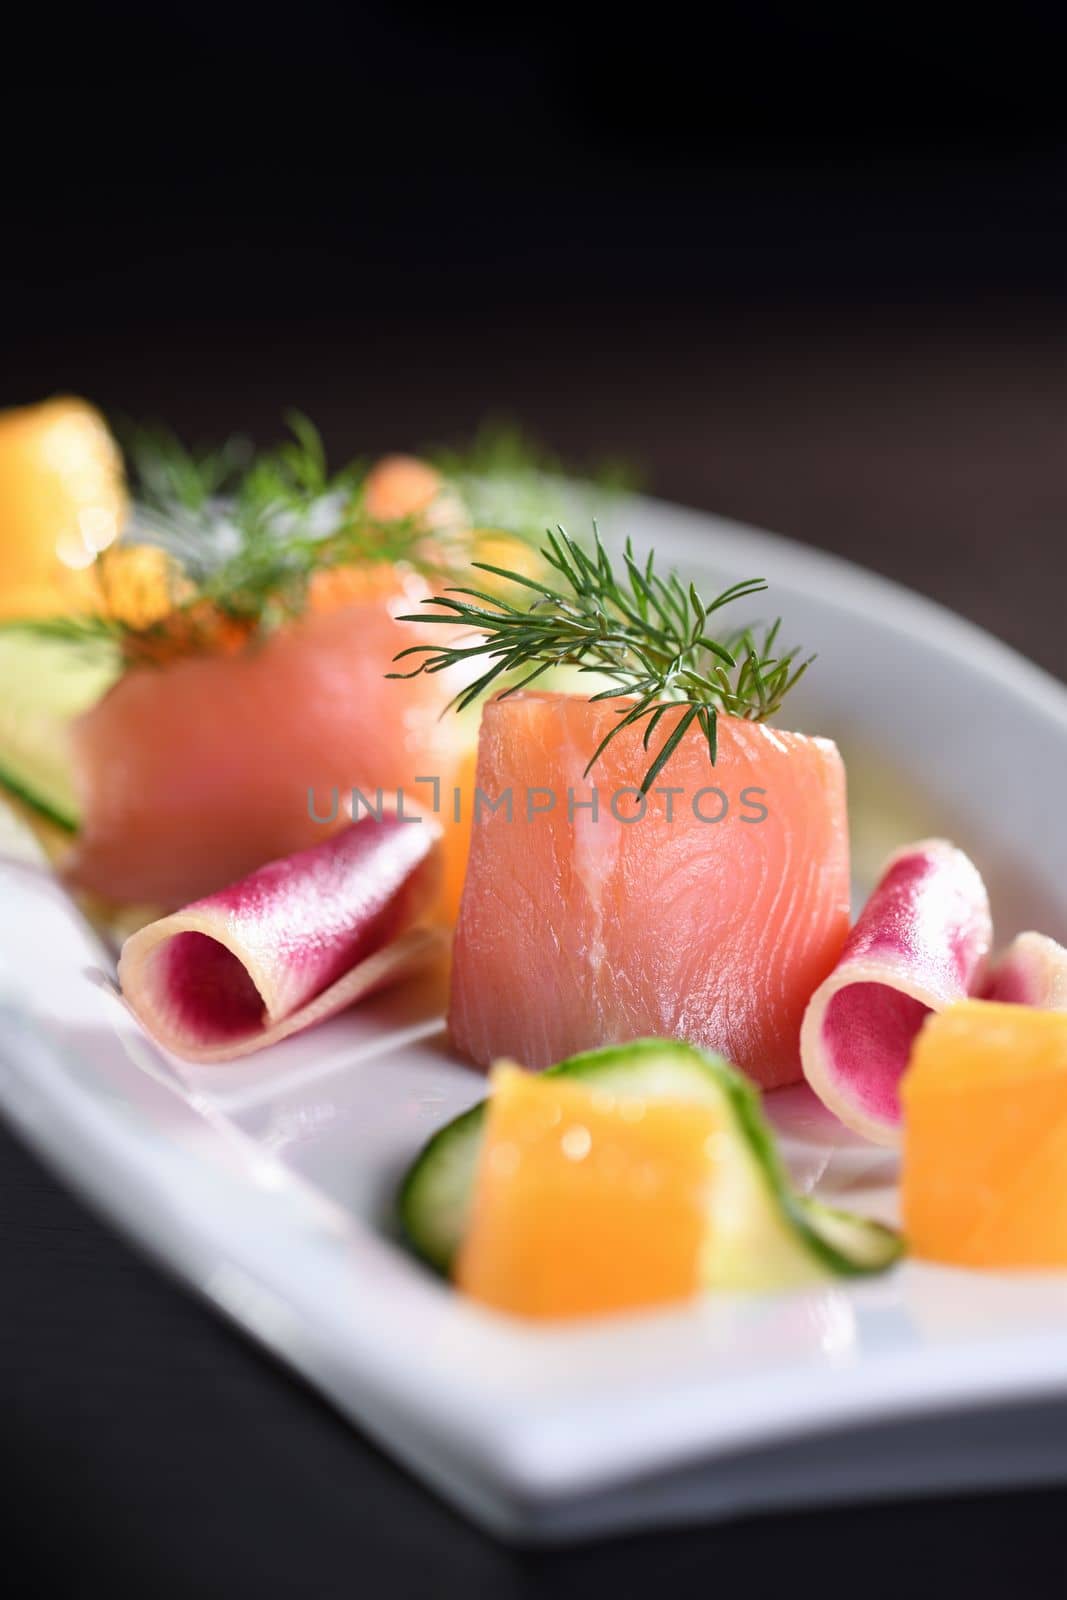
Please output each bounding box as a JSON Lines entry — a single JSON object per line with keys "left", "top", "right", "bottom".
{"left": 64, "top": 582, "right": 470, "bottom": 920}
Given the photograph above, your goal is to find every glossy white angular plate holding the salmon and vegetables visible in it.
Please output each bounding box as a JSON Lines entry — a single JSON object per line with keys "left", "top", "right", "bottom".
{"left": 0, "top": 501, "right": 1067, "bottom": 1539}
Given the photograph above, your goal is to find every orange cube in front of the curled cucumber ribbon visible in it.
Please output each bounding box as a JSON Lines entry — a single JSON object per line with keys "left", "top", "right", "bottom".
{"left": 456, "top": 1064, "right": 720, "bottom": 1317}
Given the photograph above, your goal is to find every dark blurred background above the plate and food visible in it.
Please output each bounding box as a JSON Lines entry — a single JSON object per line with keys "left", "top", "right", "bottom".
{"left": 0, "top": 0, "right": 1067, "bottom": 670}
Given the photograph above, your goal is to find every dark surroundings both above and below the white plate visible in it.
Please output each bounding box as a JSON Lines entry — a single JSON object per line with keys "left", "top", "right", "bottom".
{"left": 0, "top": 0, "right": 1067, "bottom": 1597}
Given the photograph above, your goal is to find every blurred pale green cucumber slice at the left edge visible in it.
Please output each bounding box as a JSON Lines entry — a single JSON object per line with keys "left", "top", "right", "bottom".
{"left": 0, "top": 622, "right": 118, "bottom": 829}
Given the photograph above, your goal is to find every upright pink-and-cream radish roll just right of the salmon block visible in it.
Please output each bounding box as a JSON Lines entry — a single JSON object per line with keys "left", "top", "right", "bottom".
{"left": 800, "top": 838, "right": 992, "bottom": 1144}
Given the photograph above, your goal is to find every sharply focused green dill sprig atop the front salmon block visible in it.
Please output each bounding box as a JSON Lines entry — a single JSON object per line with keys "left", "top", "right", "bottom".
{"left": 389, "top": 525, "right": 814, "bottom": 794}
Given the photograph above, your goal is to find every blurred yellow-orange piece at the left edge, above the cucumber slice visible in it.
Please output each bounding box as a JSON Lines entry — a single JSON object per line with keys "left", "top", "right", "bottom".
{"left": 0, "top": 398, "right": 126, "bottom": 618}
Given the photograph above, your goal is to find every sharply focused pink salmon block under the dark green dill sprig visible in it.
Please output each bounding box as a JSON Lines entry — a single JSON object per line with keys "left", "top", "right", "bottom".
{"left": 450, "top": 690, "right": 848, "bottom": 1088}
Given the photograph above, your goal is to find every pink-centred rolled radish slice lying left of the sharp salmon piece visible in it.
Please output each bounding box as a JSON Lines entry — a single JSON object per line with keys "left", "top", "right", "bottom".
{"left": 118, "top": 814, "right": 445, "bottom": 1061}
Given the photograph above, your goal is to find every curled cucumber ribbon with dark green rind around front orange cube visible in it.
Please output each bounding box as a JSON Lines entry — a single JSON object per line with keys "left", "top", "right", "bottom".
{"left": 397, "top": 1038, "right": 902, "bottom": 1290}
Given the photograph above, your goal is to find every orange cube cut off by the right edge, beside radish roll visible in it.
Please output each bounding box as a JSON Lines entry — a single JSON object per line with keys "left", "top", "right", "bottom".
{"left": 902, "top": 1000, "right": 1067, "bottom": 1267}
